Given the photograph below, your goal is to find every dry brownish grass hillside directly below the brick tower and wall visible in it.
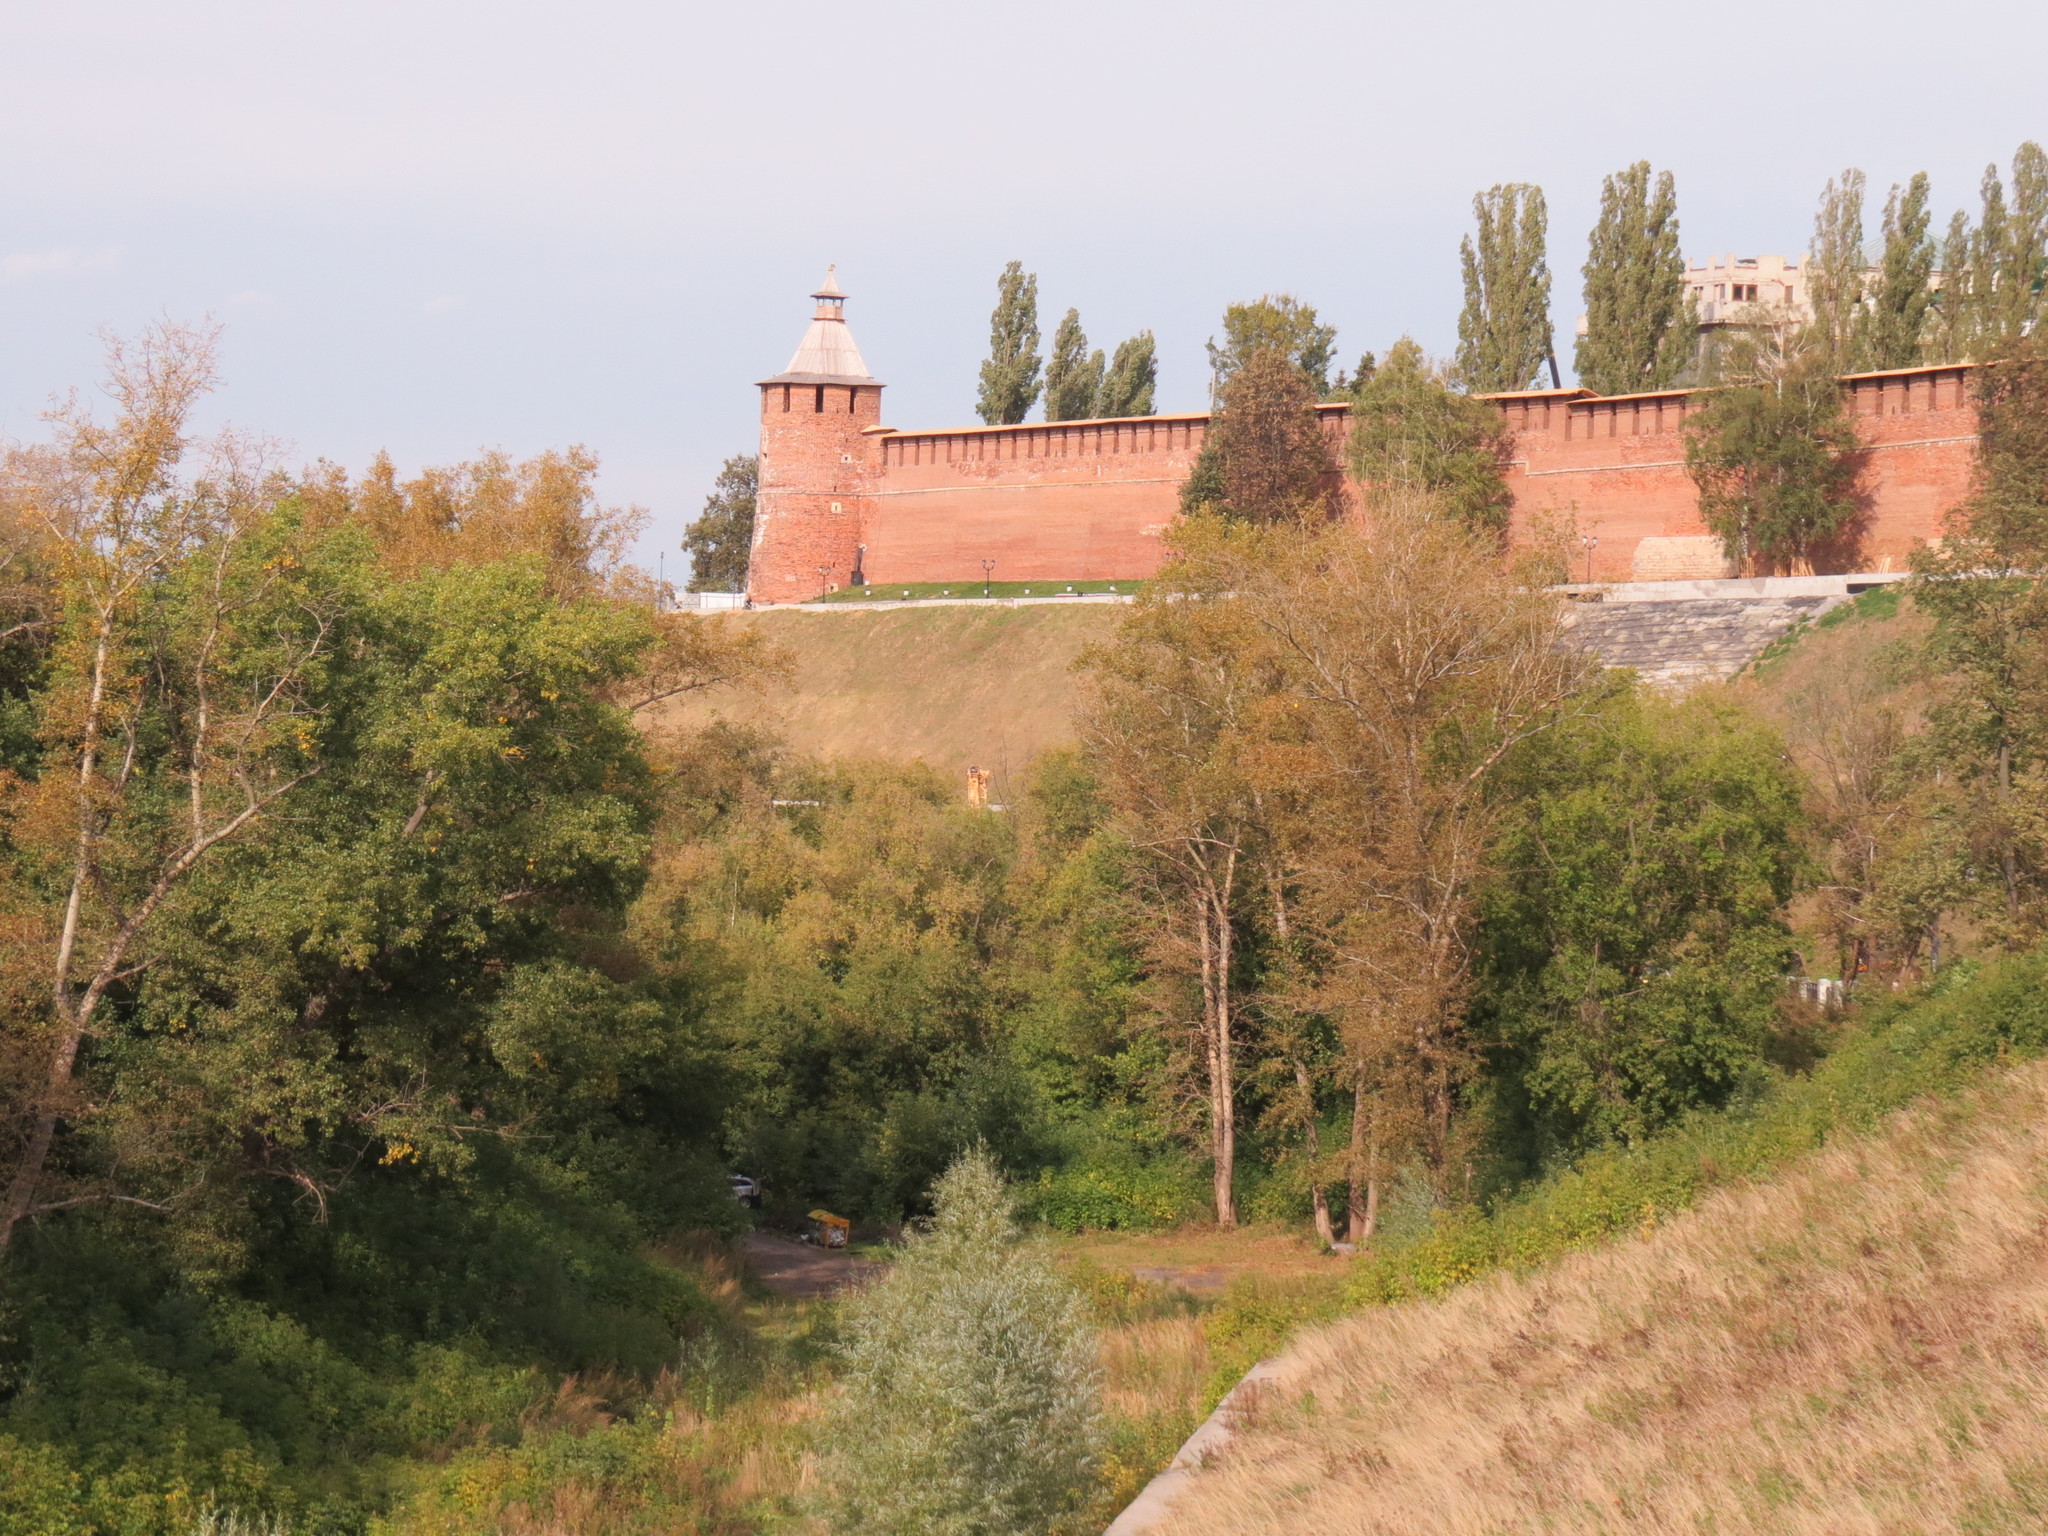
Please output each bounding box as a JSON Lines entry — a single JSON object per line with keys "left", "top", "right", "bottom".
{"left": 672, "top": 602, "right": 1124, "bottom": 782}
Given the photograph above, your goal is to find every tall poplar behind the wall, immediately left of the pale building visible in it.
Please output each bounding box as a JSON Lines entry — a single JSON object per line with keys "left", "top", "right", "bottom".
{"left": 1575, "top": 160, "right": 1696, "bottom": 395}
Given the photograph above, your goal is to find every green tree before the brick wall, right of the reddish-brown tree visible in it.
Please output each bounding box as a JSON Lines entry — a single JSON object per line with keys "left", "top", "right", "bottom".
{"left": 1350, "top": 336, "right": 1513, "bottom": 530}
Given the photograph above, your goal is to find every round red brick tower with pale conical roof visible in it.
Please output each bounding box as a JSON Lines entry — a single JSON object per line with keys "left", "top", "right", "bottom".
{"left": 748, "top": 268, "right": 883, "bottom": 602}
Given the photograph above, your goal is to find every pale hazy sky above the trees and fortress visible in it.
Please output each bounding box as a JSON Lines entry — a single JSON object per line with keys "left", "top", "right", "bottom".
{"left": 0, "top": 0, "right": 2048, "bottom": 575}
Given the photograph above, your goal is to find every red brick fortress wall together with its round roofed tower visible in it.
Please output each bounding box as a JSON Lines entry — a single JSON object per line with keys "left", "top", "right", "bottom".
{"left": 748, "top": 279, "right": 1976, "bottom": 602}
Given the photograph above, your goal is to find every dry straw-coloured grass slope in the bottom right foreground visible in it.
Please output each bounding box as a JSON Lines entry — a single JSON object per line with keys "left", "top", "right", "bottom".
{"left": 1161, "top": 1063, "right": 2048, "bottom": 1536}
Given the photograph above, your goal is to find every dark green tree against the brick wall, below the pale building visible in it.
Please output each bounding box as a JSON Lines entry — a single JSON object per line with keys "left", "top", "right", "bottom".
{"left": 1686, "top": 352, "right": 1864, "bottom": 575}
